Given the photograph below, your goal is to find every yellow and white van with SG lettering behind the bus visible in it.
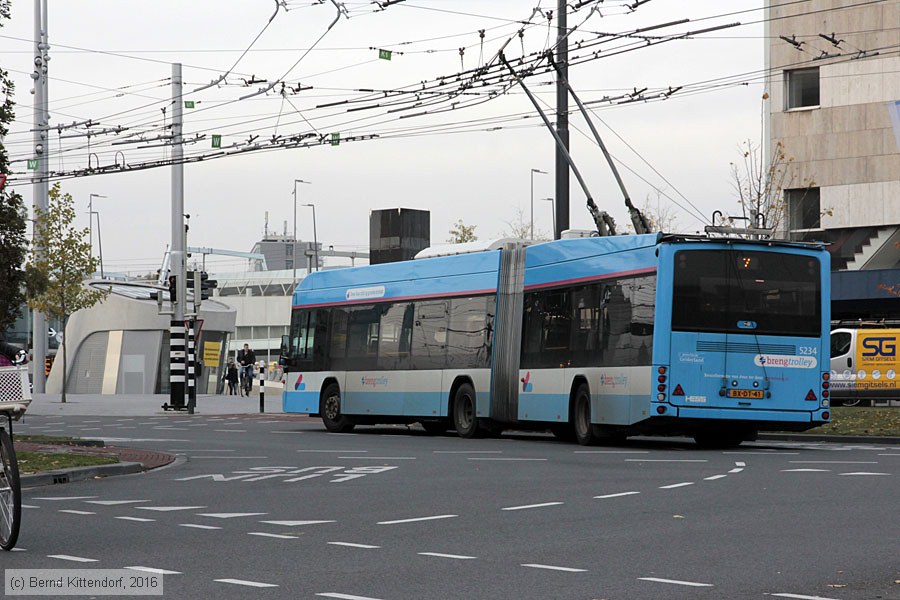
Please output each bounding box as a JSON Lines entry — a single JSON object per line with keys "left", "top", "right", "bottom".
{"left": 831, "top": 328, "right": 900, "bottom": 406}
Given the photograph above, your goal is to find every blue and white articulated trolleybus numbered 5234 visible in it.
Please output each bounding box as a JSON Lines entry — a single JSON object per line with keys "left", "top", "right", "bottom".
{"left": 282, "top": 234, "right": 830, "bottom": 446}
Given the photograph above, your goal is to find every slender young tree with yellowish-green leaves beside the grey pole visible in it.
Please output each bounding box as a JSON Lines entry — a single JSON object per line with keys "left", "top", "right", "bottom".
{"left": 28, "top": 183, "right": 108, "bottom": 402}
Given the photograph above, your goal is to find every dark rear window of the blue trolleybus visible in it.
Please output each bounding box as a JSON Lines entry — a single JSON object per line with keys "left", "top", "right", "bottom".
{"left": 672, "top": 250, "right": 822, "bottom": 337}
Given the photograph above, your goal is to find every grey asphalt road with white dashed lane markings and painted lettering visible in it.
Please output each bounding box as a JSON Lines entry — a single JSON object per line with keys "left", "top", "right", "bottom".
{"left": 8, "top": 413, "right": 900, "bottom": 600}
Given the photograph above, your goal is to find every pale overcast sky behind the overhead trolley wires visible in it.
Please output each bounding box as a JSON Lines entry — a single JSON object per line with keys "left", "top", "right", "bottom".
{"left": 0, "top": 0, "right": 764, "bottom": 274}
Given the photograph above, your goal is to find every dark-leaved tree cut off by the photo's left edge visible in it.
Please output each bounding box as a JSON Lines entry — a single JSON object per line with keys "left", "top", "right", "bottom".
{"left": 0, "top": 0, "right": 28, "bottom": 337}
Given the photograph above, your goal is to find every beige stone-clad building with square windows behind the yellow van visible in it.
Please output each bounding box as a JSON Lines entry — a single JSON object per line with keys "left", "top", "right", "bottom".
{"left": 766, "top": 0, "right": 900, "bottom": 318}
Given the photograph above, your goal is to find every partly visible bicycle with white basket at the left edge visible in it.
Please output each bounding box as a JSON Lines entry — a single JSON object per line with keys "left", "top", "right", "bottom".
{"left": 0, "top": 352, "right": 31, "bottom": 550}
